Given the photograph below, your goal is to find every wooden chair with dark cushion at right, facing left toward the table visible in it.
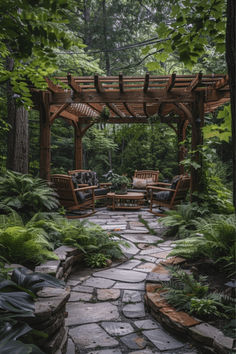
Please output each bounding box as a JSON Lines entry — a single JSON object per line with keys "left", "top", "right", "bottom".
{"left": 147, "top": 175, "right": 190, "bottom": 216}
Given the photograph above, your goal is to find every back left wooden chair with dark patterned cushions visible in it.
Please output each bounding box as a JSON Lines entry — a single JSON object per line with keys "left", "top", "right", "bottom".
{"left": 68, "top": 170, "right": 111, "bottom": 200}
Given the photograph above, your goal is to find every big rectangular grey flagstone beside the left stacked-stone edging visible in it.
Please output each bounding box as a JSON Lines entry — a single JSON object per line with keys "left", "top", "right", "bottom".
{"left": 66, "top": 302, "right": 119, "bottom": 326}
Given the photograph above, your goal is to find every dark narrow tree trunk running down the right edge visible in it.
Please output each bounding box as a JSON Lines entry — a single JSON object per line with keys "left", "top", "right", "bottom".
{"left": 226, "top": 0, "right": 236, "bottom": 209}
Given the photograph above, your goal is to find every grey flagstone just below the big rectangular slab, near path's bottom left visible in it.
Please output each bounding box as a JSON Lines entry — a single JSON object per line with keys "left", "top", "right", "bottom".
{"left": 69, "top": 323, "right": 119, "bottom": 350}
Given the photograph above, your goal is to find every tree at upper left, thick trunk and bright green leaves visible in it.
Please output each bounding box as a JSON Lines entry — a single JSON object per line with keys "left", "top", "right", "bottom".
{"left": 0, "top": 0, "right": 82, "bottom": 173}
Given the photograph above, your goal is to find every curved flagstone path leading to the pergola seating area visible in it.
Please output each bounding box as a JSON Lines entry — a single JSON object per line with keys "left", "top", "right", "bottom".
{"left": 66, "top": 208, "right": 201, "bottom": 354}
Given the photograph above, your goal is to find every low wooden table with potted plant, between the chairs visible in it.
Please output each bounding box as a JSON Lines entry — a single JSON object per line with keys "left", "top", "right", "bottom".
{"left": 107, "top": 192, "right": 144, "bottom": 210}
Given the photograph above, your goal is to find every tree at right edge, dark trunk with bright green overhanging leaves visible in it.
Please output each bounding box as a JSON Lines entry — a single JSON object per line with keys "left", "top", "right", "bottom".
{"left": 145, "top": 0, "right": 236, "bottom": 207}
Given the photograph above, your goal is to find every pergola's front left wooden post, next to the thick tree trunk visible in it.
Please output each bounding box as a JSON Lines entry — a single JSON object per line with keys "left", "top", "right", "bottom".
{"left": 39, "top": 92, "right": 51, "bottom": 180}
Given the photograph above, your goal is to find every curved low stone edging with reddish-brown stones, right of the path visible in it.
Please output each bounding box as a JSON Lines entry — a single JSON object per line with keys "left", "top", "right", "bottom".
{"left": 145, "top": 257, "right": 236, "bottom": 354}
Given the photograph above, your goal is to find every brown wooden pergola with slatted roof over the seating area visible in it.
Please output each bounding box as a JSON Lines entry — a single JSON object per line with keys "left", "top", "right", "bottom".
{"left": 32, "top": 73, "right": 230, "bottom": 190}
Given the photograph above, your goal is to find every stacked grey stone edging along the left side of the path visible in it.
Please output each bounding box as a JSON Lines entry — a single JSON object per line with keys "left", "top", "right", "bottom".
{"left": 32, "top": 246, "right": 83, "bottom": 354}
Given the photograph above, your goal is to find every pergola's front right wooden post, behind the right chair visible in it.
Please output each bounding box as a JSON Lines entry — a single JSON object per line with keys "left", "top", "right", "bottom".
{"left": 191, "top": 92, "right": 205, "bottom": 192}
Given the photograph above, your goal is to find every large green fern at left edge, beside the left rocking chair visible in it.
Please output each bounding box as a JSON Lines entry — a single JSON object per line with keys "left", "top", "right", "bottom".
{"left": 0, "top": 171, "right": 59, "bottom": 219}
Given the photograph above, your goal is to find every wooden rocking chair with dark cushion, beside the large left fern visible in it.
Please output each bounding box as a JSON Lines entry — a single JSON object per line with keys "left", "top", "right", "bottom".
{"left": 51, "top": 174, "right": 97, "bottom": 219}
